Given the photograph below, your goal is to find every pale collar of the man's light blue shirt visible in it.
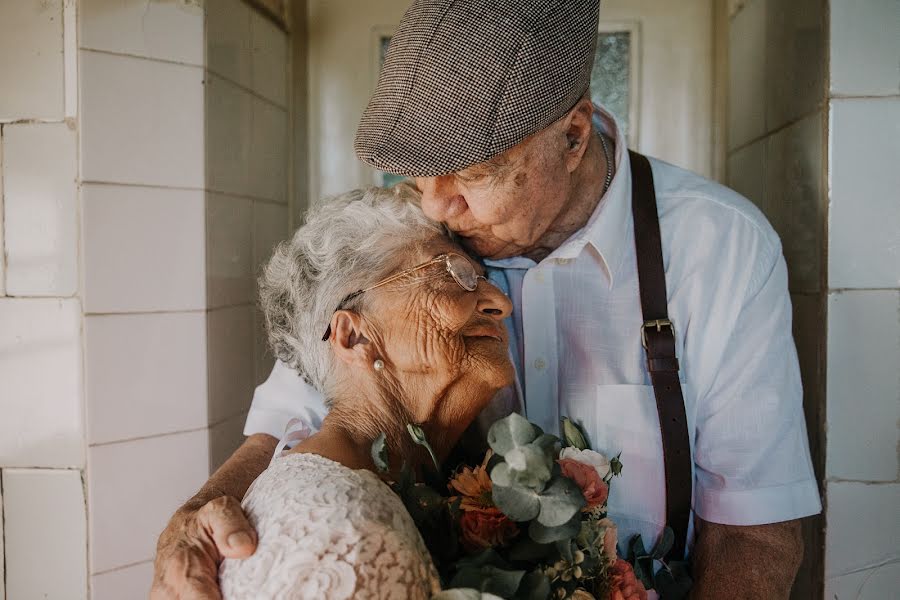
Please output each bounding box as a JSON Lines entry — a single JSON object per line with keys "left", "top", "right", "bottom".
{"left": 484, "top": 106, "right": 632, "bottom": 287}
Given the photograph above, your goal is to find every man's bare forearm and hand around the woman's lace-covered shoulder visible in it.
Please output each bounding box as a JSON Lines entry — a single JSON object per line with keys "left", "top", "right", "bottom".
{"left": 150, "top": 433, "right": 278, "bottom": 600}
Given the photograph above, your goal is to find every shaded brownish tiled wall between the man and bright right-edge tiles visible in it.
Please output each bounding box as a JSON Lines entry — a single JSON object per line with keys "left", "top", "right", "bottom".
{"left": 727, "top": 0, "right": 828, "bottom": 599}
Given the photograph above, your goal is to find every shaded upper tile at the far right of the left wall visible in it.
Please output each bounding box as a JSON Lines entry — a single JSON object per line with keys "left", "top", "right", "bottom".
{"left": 250, "top": 12, "right": 288, "bottom": 108}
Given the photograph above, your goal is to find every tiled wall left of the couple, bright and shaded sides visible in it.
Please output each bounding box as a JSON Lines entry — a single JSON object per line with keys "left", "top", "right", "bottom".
{"left": 0, "top": 0, "right": 289, "bottom": 600}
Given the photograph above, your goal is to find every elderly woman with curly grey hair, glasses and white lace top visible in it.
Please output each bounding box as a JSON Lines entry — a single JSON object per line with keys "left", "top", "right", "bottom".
{"left": 220, "top": 186, "right": 513, "bottom": 599}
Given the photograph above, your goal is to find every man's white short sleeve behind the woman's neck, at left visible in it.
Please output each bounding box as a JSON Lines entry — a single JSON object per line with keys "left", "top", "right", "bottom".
{"left": 244, "top": 361, "right": 327, "bottom": 439}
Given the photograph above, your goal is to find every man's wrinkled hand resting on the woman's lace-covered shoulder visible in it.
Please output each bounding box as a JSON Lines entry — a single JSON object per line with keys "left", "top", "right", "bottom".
{"left": 150, "top": 496, "right": 257, "bottom": 600}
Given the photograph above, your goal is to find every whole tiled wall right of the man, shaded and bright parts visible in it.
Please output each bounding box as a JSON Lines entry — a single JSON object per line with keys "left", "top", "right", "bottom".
{"left": 728, "top": 0, "right": 900, "bottom": 600}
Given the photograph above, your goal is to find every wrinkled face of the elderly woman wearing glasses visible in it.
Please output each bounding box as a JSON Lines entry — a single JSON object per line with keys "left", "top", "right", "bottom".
{"left": 363, "top": 240, "right": 514, "bottom": 412}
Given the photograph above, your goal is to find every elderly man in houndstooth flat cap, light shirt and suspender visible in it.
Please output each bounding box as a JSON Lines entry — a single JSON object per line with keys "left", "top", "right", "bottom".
{"left": 154, "top": 0, "right": 821, "bottom": 598}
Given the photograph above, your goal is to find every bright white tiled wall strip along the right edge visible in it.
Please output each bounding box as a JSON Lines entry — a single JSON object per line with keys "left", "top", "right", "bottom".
{"left": 825, "top": 0, "right": 900, "bottom": 600}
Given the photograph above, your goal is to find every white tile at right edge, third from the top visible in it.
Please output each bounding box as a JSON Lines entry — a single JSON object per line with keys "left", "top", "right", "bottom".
{"left": 826, "top": 290, "right": 900, "bottom": 481}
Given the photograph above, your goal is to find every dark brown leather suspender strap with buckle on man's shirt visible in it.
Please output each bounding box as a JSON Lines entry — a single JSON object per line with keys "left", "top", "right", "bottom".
{"left": 629, "top": 151, "right": 693, "bottom": 560}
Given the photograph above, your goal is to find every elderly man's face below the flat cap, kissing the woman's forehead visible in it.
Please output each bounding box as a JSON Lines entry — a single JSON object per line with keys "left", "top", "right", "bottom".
{"left": 415, "top": 127, "right": 568, "bottom": 259}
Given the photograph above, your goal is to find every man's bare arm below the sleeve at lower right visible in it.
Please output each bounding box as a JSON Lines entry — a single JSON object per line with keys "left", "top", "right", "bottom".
{"left": 691, "top": 517, "right": 803, "bottom": 600}
